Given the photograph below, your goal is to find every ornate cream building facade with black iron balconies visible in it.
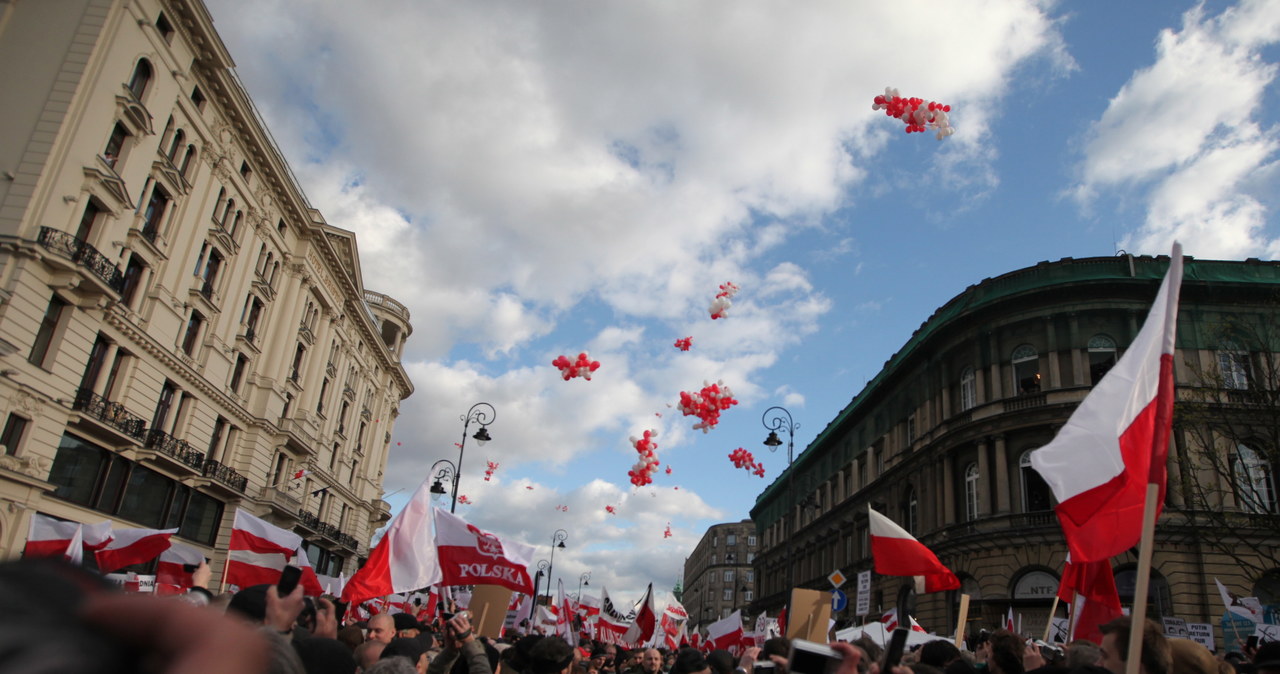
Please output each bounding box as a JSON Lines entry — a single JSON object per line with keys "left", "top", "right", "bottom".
{"left": 0, "top": 0, "right": 413, "bottom": 576}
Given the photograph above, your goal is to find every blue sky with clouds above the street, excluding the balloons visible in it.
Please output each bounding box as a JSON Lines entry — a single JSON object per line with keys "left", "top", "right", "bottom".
{"left": 209, "top": 0, "right": 1280, "bottom": 597}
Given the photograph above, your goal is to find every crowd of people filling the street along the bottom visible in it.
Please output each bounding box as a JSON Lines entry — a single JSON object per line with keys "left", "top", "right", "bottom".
{"left": 0, "top": 560, "right": 1280, "bottom": 674}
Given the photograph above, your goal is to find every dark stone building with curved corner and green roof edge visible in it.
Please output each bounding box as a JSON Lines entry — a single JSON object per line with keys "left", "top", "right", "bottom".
{"left": 747, "top": 255, "right": 1280, "bottom": 632}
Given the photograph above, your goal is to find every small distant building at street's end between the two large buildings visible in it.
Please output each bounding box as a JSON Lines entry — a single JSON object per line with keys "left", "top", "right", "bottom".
{"left": 682, "top": 519, "right": 760, "bottom": 625}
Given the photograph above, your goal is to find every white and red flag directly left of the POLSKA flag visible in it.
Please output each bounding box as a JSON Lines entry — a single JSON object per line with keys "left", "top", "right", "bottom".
{"left": 342, "top": 478, "right": 440, "bottom": 604}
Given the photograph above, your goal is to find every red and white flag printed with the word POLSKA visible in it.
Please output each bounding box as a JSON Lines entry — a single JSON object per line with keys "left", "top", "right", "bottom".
{"left": 435, "top": 508, "right": 536, "bottom": 595}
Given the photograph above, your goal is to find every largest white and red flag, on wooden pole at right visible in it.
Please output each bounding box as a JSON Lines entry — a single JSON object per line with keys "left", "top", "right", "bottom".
{"left": 1032, "top": 243, "right": 1183, "bottom": 563}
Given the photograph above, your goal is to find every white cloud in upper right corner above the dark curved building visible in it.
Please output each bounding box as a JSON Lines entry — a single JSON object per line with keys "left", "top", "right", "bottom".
{"left": 1071, "top": 0, "right": 1280, "bottom": 258}
